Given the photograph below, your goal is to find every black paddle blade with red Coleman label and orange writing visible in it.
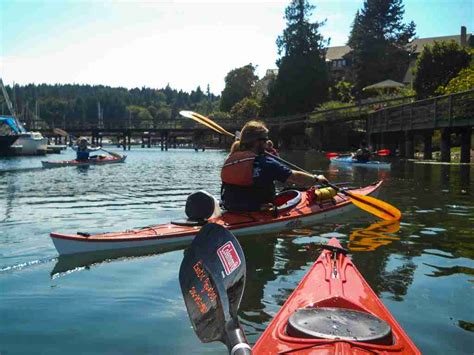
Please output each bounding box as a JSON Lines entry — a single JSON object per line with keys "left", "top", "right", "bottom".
{"left": 179, "top": 223, "right": 251, "bottom": 355}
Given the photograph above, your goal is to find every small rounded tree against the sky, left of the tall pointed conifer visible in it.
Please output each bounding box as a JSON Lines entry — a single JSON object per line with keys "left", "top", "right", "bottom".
{"left": 220, "top": 63, "right": 258, "bottom": 112}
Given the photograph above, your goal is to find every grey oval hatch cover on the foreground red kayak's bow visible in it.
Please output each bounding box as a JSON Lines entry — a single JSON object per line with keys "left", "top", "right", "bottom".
{"left": 286, "top": 307, "right": 393, "bottom": 345}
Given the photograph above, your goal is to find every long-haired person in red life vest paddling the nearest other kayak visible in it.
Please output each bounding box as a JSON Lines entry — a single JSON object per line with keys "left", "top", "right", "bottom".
{"left": 221, "top": 121, "right": 327, "bottom": 211}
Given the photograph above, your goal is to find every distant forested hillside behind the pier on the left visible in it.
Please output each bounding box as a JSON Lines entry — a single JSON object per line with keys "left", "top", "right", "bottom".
{"left": 5, "top": 84, "right": 219, "bottom": 128}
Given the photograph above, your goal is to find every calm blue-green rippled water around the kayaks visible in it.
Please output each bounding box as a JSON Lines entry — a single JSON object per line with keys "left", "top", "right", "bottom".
{"left": 0, "top": 149, "right": 474, "bottom": 355}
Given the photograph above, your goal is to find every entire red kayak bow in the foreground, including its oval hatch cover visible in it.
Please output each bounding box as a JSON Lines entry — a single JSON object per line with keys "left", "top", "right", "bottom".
{"left": 252, "top": 238, "right": 421, "bottom": 354}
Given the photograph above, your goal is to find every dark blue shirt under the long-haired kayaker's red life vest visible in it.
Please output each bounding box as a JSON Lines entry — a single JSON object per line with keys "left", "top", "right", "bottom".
{"left": 221, "top": 155, "right": 292, "bottom": 211}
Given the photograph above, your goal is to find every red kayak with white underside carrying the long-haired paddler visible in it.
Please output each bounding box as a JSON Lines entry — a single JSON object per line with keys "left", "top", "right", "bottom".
{"left": 50, "top": 182, "right": 382, "bottom": 255}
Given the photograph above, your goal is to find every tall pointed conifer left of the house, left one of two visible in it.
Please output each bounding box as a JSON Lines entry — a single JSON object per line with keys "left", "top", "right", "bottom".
{"left": 264, "top": 0, "right": 329, "bottom": 115}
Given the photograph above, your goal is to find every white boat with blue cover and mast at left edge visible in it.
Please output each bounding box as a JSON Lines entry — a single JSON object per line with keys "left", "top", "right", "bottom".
{"left": 0, "top": 78, "right": 48, "bottom": 155}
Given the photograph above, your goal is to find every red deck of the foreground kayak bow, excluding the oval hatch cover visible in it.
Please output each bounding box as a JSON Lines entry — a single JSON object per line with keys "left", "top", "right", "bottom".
{"left": 253, "top": 238, "right": 421, "bottom": 355}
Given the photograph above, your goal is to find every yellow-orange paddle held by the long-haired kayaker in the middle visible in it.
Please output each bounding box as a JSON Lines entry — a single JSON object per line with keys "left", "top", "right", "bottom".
{"left": 180, "top": 111, "right": 402, "bottom": 220}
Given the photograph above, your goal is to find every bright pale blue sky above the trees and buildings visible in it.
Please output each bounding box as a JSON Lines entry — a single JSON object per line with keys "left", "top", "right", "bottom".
{"left": 0, "top": 0, "right": 474, "bottom": 94}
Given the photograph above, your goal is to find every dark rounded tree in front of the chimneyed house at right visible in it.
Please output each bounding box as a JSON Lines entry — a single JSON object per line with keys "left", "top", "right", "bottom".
{"left": 413, "top": 41, "right": 471, "bottom": 99}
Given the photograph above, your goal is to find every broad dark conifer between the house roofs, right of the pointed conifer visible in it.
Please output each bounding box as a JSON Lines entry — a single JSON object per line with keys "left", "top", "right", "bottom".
{"left": 348, "top": 0, "right": 416, "bottom": 93}
